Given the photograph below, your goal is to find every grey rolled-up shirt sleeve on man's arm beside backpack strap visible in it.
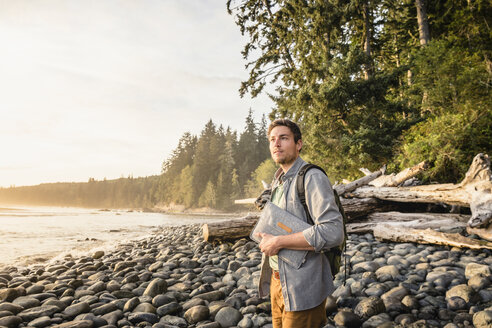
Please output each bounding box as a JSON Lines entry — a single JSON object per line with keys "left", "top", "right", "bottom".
{"left": 302, "top": 169, "right": 344, "bottom": 252}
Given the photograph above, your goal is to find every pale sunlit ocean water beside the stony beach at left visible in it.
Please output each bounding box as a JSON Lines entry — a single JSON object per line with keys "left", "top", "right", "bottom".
{"left": 0, "top": 206, "right": 227, "bottom": 268}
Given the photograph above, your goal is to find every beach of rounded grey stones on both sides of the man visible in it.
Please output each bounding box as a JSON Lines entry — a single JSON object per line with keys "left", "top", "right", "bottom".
{"left": 0, "top": 225, "right": 492, "bottom": 328}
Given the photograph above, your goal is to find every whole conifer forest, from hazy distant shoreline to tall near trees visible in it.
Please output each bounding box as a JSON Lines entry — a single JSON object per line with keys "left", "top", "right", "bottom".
{"left": 0, "top": 0, "right": 492, "bottom": 210}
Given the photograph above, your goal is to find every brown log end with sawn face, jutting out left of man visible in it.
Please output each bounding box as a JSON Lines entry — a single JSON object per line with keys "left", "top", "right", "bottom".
{"left": 202, "top": 214, "right": 258, "bottom": 242}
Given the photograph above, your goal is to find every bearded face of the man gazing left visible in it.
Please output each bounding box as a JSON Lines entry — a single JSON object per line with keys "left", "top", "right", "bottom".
{"left": 269, "top": 126, "right": 302, "bottom": 166}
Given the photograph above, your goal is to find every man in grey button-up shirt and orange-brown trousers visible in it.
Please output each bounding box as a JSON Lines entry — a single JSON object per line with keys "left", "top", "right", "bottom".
{"left": 259, "top": 119, "right": 344, "bottom": 328}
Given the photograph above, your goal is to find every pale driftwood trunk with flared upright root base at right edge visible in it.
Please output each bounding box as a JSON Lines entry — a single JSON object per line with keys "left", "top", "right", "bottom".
{"left": 352, "top": 154, "right": 492, "bottom": 227}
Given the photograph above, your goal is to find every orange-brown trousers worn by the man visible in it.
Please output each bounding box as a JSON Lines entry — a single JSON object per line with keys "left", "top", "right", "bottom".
{"left": 270, "top": 275, "right": 326, "bottom": 328}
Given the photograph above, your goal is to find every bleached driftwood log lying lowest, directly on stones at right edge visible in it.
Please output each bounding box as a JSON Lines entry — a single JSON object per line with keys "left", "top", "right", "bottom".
{"left": 374, "top": 225, "right": 492, "bottom": 249}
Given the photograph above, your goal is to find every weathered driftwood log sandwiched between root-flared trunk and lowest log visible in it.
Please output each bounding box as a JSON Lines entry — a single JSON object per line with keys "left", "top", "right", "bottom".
{"left": 347, "top": 212, "right": 470, "bottom": 234}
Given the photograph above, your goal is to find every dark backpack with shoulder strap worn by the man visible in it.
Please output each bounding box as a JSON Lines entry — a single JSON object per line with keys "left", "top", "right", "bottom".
{"left": 296, "top": 164, "right": 347, "bottom": 278}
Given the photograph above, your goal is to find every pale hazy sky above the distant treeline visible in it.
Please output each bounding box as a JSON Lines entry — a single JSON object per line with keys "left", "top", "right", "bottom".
{"left": 0, "top": 0, "right": 272, "bottom": 187}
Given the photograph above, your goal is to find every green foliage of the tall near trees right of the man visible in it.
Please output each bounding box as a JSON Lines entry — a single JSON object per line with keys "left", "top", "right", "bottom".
{"left": 227, "top": 0, "right": 492, "bottom": 180}
